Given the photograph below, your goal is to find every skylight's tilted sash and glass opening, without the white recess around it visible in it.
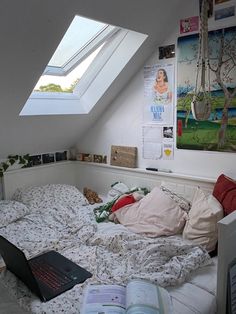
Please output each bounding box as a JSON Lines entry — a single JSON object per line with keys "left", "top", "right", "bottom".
{"left": 34, "top": 16, "right": 116, "bottom": 92}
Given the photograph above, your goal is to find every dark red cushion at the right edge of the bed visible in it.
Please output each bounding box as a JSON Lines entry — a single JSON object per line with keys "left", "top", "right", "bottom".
{"left": 213, "top": 174, "right": 236, "bottom": 215}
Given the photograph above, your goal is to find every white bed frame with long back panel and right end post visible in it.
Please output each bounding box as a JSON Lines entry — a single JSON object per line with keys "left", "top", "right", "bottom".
{"left": 3, "top": 161, "right": 236, "bottom": 314}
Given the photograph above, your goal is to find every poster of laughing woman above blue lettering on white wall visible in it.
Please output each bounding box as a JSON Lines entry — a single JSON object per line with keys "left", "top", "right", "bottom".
{"left": 143, "top": 64, "right": 174, "bottom": 125}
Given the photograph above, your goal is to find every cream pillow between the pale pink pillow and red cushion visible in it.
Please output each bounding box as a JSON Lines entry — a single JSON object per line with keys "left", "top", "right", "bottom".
{"left": 183, "top": 188, "right": 223, "bottom": 252}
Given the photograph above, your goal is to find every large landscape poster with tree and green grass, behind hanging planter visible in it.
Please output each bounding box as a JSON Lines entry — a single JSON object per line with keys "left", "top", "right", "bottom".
{"left": 176, "top": 27, "right": 236, "bottom": 152}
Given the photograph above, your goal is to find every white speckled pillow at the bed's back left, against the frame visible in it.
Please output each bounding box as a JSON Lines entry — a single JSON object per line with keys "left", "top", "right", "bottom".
{"left": 13, "top": 184, "right": 88, "bottom": 211}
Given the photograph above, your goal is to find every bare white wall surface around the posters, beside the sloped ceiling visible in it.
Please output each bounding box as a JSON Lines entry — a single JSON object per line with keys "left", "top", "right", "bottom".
{"left": 77, "top": 1, "right": 236, "bottom": 178}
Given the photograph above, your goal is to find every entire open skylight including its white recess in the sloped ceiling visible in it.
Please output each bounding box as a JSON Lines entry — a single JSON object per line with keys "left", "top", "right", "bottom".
{"left": 20, "top": 16, "right": 147, "bottom": 115}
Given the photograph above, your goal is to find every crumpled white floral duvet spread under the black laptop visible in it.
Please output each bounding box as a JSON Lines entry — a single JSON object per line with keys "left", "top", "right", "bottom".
{"left": 0, "top": 184, "right": 210, "bottom": 314}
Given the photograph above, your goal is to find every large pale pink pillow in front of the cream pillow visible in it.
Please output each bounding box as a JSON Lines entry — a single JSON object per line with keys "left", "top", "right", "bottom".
{"left": 114, "top": 187, "right": 187, "bottom": 237}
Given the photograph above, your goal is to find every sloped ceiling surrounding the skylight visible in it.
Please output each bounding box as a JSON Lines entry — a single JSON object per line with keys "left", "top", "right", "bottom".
{"left": 0, "top": 0, "right": 189, "bottom": 159}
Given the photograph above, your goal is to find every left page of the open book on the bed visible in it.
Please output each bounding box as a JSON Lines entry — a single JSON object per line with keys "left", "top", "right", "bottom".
{"left": 82, "top": 285, "right": 126, "bottom": 314}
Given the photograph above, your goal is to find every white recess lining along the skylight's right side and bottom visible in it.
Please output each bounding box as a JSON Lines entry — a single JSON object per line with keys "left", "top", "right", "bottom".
{"left": 19, "top": 29, "right": 148, "bottom": 116}
